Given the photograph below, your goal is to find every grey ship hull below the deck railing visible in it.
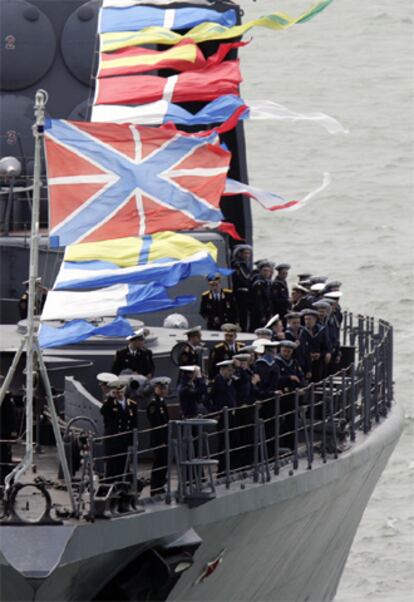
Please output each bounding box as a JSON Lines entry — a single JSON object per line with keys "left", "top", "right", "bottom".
{"left": 1, "top": 398, "right": 402, "bottom": 601}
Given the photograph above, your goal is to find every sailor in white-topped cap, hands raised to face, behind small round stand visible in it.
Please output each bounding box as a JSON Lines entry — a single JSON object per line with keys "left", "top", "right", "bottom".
{"left": 177, "top": 365, "right": 208, "bottom": 418}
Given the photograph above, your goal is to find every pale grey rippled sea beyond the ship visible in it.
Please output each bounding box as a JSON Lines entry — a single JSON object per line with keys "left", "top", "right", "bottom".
{"left": 240, "top": 0, "right": 414, "bottom": 602}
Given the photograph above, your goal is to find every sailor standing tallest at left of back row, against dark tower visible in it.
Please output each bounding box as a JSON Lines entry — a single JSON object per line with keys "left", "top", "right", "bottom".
{"left": 231, "top": 245, "right": 253, "bottom": 332}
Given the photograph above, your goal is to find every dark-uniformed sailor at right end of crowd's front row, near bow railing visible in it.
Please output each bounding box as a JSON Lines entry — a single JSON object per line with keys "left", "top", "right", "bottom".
{"left": 300, "top": 309, "right": 331, "bottom": 382}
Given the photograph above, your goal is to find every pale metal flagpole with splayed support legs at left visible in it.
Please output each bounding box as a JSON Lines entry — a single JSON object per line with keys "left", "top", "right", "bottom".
{"left": 0, "top": 90, "right": 75, "bottom": 509}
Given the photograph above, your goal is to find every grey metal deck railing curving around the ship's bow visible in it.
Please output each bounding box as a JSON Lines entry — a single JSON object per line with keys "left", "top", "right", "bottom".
{"left": 0, "top": 312, "right": 393, "bottom": 520}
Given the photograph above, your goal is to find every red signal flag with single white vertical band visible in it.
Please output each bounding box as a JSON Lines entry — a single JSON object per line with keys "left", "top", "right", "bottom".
{"left": 94, "top": 60, "right": 242, "bottom": 105}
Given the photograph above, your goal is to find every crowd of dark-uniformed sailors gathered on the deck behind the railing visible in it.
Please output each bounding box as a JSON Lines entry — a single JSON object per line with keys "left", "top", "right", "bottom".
{"left": 98, "top": 255, "right": 342, "bottom": 495}
